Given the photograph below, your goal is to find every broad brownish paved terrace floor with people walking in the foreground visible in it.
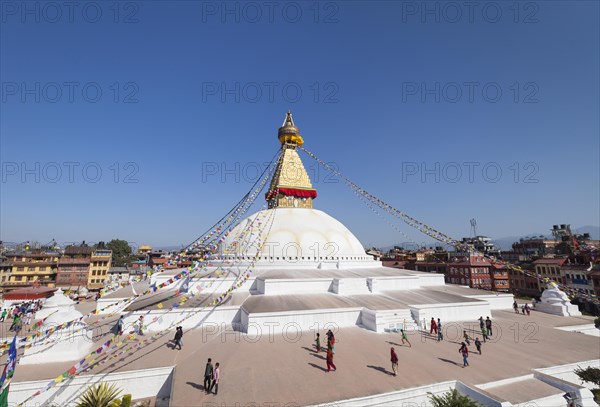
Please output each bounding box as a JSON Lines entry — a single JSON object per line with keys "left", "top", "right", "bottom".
{"left": 5, "top": 310, "right": 600, "bottom": 407}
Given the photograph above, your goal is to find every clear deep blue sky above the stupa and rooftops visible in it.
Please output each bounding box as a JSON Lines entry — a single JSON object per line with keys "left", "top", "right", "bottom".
{"left": 0, "top": 1, "right": 600, "bottom": 246}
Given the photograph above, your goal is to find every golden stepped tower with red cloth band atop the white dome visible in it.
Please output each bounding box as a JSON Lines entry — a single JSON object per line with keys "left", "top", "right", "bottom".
{"left": 265, "top": 112, "right": 317, "bottom": 208}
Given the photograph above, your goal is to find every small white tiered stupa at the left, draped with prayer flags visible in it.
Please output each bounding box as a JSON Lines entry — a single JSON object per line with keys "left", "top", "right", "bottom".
{"left": 19, "top": 289, "right": 92, "bottom": 364}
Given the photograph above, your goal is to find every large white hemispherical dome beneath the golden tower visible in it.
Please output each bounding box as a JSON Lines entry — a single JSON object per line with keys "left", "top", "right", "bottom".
{"left": 219, "top": 208, "right": 374, "bottom": 267}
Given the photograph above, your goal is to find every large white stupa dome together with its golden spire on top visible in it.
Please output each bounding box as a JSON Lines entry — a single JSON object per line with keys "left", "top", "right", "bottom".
{"left": 221, "top": 112, "right": 375, "bottom": 269}
